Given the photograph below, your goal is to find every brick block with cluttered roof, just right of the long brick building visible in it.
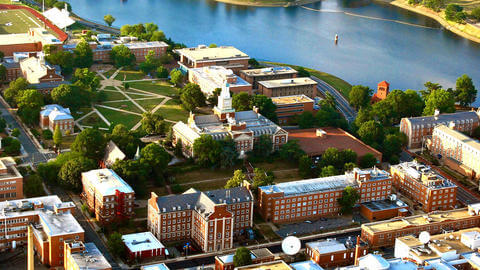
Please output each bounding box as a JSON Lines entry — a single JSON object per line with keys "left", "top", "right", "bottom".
{"left": 390, "top": 161, "right": 457, "bottom": 212}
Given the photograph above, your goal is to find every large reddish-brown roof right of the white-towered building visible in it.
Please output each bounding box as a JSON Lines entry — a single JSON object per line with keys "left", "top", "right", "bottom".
{"left": 288, "top": 127, "right": 382, "bottom": 161}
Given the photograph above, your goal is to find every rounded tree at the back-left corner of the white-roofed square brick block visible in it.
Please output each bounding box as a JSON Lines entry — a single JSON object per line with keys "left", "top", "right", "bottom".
{"left": 58, "top": 157, "right": 97, "bottom": 191}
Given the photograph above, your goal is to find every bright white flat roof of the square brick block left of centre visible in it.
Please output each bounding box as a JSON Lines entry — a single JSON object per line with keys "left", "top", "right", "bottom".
{"left": 82, "top": 169, "right": 134, "bottom": 196}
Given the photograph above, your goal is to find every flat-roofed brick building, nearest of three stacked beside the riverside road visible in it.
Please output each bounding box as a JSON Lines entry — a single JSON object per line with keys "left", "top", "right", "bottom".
{"left": 272, "top": 95, "right": 315, "bottom": 124}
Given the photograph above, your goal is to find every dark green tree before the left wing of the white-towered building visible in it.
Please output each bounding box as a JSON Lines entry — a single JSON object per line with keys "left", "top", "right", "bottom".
{"left": 193, "top": 134, "right": 222, "bottom": 167}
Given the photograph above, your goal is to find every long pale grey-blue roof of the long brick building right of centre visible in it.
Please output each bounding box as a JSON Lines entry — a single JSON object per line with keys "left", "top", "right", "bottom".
{"left": 259, "top": 168, "right": 390, "bottom": 196}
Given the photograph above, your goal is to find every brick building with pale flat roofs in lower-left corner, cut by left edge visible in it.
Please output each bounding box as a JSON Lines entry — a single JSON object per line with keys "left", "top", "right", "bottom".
{"left": 0, "top": 196, "right": 84, "bottom": 267}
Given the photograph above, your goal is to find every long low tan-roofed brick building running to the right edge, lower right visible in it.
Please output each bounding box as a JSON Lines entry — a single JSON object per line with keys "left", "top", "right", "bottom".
{"left": 361, "top": 204, "right": 480, "bottom": 248}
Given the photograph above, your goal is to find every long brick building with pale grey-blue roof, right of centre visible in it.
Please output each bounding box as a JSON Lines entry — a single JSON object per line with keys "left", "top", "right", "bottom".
{"left": 258, "top": 168, "right": 392, "bottom": 223}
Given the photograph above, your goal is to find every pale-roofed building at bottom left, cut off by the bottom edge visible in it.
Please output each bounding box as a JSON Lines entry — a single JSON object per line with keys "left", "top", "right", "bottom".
{"left": 63, "top": 241, "right": 112, "bottom": 270}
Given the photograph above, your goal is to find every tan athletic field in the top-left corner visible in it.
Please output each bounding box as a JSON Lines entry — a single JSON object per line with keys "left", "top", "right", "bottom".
{"left": 0, "top": 9, "right": 42, "bottom": 35}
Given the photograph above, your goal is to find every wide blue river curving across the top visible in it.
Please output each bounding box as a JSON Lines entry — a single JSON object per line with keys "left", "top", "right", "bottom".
{"left": 66, "top": 0, "right": 480, "bottom": 103}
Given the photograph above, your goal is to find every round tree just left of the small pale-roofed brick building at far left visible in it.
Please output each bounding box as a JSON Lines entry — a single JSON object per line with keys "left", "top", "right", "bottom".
{"left": 16, "top": 89, "right": 43, "bottom": 125}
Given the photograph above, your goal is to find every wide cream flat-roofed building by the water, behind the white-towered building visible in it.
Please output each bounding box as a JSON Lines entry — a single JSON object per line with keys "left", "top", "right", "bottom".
{"left": 174, "top": 45, "right": 250, "bottom": 73}
